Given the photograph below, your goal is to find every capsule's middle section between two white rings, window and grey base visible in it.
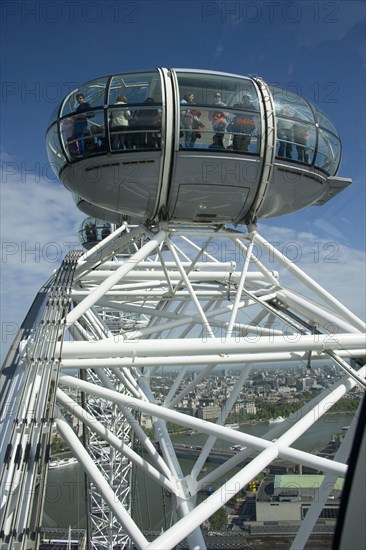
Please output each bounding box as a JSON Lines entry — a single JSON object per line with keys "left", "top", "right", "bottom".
{"left": 167, "top": 70, "right": 261, "bottom": 223}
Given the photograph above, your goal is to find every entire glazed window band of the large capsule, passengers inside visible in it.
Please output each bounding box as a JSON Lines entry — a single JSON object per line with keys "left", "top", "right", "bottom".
{"left": 47, "top": 73, "right": 341, "bottom": 181}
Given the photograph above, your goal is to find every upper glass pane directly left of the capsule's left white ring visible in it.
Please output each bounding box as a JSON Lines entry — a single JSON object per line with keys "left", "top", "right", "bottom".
{"left": 108, "top": 71, "right": 162, "bottom": 105}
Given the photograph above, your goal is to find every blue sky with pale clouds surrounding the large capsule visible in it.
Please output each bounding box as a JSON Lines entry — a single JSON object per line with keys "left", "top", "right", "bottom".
{"left": 0, "top": 0, "right": 366, "bottom": 364}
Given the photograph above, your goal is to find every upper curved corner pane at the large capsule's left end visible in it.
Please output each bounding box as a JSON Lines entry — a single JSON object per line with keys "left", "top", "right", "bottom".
{"left": 60, "top": 77, "right": 108, "bottom": 116}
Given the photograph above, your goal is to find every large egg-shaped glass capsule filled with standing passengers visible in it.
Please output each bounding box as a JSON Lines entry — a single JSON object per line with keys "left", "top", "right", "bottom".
{"left": 47, "top": 69, "right": 351, "bottom": 224}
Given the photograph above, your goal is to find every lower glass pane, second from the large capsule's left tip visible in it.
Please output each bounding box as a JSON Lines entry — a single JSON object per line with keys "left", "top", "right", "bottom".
{"left": 60, "top": 111, "right": 106, "bottom": 160}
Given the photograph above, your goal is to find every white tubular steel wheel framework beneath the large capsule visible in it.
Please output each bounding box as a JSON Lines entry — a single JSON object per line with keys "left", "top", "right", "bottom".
{"left": 1, "top": 223, "right": 366, "bottom": 550}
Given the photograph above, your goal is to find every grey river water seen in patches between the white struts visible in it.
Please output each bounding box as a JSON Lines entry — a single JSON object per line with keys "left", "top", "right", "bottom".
{"left": 43, "top": 414, "right": 353, "bottom": 529}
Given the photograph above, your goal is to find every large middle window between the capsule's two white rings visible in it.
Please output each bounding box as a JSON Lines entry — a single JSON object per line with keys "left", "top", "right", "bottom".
{"left": 177, "top": 72, "right": 260, "bottom": 153}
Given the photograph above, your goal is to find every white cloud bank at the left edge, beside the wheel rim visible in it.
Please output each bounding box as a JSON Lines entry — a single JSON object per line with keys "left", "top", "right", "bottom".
{"left": 1, "top": 153, "right": 86, "bottom": 359}
